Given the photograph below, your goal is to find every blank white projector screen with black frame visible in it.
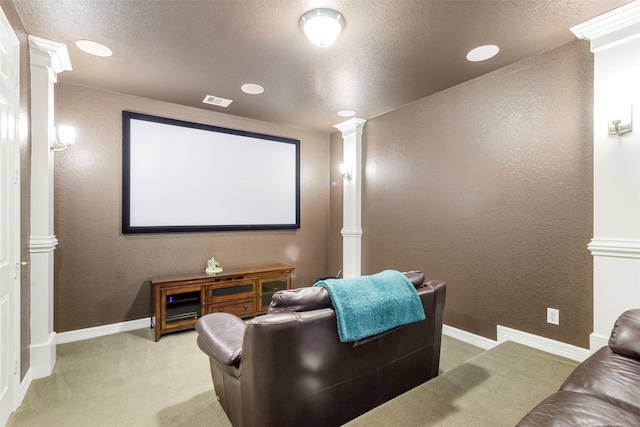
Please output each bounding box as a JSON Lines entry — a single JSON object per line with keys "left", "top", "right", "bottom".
{"left": 123, "top": 112, "right": 299, "bottom": 233}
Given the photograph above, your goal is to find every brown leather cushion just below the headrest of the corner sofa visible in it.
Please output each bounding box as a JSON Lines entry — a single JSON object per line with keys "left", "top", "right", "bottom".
{"left": 560, "top": 347, "right": 640, "bottom": 418}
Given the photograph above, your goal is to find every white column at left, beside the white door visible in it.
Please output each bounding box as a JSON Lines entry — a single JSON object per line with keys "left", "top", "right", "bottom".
{"left": 29, "top": 36, "right": 71, "bottom": 379}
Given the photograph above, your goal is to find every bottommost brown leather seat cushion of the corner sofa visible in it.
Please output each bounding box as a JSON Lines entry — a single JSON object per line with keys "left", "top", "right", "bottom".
{"left": 517, "top": 391, "right": 640, "bottom": 427}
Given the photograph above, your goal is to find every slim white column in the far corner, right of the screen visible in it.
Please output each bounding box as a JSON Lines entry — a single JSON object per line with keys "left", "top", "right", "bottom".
{"left": 334, "top": 117, "right": 366, "bottom": 277}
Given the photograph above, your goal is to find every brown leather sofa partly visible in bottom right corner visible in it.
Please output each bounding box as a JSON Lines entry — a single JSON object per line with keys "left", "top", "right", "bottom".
{"left": 518, "top": 309, "right": 640, "bottom": 427}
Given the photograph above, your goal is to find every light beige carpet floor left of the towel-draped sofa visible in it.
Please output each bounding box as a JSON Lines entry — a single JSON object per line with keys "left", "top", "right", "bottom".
{"left": 7, "top": 329, "right": 231, "bottom": 427}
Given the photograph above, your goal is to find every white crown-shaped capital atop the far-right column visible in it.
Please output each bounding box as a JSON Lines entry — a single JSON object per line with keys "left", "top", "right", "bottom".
{"left": 570, "top": 1, "right": 640, "bottom": 52}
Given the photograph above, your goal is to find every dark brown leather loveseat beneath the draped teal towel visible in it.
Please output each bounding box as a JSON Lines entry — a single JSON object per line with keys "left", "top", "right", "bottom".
{"left": 196, "top": 272, "right": 445, "bottom": 427}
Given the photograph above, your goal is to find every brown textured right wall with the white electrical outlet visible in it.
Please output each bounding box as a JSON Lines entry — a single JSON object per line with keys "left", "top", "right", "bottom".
{"left": 340, "top": 41, "right": 593, "bottom": 347}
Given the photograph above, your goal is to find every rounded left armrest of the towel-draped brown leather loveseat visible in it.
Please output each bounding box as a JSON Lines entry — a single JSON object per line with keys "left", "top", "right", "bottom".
{"left": 196, "top": 313, "right": 247, "bottom": 366}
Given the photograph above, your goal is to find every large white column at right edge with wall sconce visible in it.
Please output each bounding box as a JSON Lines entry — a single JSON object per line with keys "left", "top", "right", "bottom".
{"left": 571, "top": 1, "right": 640, "bottom": 353}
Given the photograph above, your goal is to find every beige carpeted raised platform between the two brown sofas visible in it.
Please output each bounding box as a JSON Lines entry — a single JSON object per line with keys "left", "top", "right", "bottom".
{"left": 346, "top": 341, "right": 578, "bottom": 427}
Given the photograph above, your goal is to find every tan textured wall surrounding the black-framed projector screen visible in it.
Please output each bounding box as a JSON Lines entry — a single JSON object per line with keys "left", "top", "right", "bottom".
{"left": 54, "top": 83, "right": 329, "bottom": 332}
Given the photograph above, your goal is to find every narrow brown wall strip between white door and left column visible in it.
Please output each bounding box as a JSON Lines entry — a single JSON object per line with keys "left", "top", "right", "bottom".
{"left": 0, "top": 0, "right": 31, "bottom": 381}
